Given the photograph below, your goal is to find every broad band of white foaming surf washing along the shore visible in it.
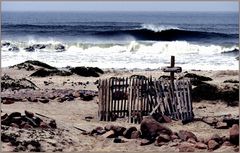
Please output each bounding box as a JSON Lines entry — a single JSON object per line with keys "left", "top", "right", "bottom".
{"left": 2, "top": 41, "right": 239, "bottom": 70}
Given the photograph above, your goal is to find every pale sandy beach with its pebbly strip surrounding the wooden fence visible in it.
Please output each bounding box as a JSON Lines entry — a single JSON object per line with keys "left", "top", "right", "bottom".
{"left": 1, "top": 61, "right": 239, "bottom": 152}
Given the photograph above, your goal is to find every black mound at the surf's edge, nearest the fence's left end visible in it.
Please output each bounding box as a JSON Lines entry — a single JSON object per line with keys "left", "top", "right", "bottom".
{"left": 70, "top": 67, "right": 104, "bottom": 77}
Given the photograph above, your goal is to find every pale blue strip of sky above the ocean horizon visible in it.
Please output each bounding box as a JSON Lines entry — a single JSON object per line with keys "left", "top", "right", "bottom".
{"left": 2, "top": 1, "right": 238, "bottom": 12}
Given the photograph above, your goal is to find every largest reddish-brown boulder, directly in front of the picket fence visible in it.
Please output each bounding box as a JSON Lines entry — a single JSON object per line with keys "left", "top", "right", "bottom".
{"left": 140, "top": 116, "right": 172, "bottom": 140}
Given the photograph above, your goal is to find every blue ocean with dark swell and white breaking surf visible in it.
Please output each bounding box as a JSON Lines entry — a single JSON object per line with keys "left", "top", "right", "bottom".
{"left": 1, "top": 12, "right": 239, "bottom": 70}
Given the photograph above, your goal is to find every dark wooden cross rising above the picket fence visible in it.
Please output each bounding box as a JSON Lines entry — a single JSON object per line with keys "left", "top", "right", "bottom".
{"left": 162, "top": 56, "right": 182, "bottom": 84}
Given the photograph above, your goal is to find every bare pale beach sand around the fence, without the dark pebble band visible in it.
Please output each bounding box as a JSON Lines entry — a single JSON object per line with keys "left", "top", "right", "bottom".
{"left": 1, "top": 65, "right": 239, "bottom": 152}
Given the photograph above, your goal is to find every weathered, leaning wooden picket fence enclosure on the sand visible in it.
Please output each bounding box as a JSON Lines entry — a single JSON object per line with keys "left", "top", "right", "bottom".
{"left": 98, "top": 77, "right": 193, "bottom": 123}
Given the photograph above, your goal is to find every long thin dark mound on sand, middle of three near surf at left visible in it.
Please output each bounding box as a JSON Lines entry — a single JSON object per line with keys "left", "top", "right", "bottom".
{"left": 30, "top": 68, "right": 72, "bottom": 77}
